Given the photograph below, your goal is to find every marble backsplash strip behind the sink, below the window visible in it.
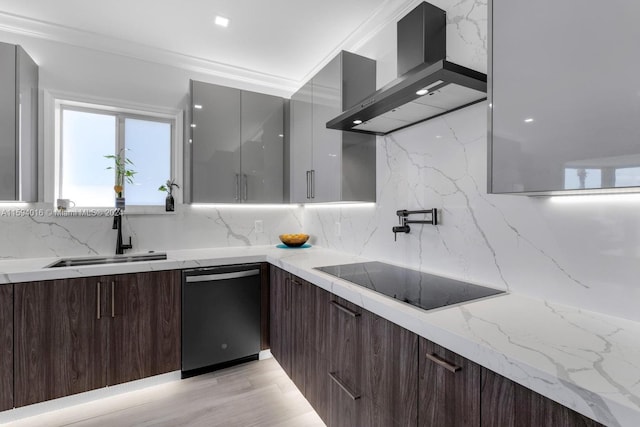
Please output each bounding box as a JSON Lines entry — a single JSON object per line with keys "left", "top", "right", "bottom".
{"left": 0, "top": 204, "right": 302, "bottom": 259}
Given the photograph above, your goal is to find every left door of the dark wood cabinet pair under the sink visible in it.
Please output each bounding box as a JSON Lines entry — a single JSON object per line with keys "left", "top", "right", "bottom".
{"left": 14, "top": 278, "right": 109, "bottom": 407}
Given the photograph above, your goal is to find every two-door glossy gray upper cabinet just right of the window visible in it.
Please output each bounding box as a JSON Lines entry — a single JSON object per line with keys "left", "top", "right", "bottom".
{"left": 191, "top": 81, "right": 284, "bottom": 203}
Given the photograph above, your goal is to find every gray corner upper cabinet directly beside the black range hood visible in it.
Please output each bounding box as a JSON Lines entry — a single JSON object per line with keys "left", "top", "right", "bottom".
{"left": 290, "top": 51, "right": 376, "bottom": 203}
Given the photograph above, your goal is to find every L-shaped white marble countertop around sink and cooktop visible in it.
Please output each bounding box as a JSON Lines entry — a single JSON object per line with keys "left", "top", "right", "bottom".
{"left": 0, "top": 246, "right": 640, "bottom": 427}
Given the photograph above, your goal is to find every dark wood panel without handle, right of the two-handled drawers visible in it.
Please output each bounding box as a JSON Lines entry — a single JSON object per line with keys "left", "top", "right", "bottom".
{"left": 362, "top": 311, "right": 420, "bottom": 427}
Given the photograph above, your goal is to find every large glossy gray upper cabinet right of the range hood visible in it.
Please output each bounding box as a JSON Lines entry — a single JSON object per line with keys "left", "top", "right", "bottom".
{"left": 489, "top": 0, "right": 640, "bottom": 194}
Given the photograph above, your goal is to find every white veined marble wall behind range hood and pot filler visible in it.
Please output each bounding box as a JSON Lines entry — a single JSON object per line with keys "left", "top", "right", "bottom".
{"left": 304, "top": 0, "right": 640, "bottom": 321}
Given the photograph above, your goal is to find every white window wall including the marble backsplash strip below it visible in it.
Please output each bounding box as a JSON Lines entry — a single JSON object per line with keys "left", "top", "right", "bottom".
{"left": 0, "top": 31, "right": 302, "bottom": 259}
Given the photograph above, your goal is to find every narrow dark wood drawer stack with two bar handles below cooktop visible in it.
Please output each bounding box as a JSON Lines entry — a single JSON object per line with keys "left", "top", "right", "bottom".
{"left": 328, "top": 296, "right": 362, "bottom": 427}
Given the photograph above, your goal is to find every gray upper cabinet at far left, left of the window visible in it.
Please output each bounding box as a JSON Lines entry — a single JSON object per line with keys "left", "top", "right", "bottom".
{"left": 0, "top": 43, "right": 38, "bottom": 202}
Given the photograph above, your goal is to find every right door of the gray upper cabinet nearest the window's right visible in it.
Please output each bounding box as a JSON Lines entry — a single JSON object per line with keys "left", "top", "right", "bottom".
{"left": 240, "top": 91, "right": 284, "bottom": 203}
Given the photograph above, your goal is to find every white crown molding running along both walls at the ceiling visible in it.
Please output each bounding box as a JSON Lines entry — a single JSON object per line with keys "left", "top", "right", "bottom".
{"left": 0, "top": 0, "right": 421, "bottom": 96}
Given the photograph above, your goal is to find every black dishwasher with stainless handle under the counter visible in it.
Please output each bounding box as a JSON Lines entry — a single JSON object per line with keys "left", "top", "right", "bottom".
{"left": 182, "top": 264, "right": 260, "bottom": 378}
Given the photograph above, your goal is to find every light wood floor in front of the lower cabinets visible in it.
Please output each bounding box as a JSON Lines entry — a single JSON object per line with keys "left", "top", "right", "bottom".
{"left": 5, "top": 358, "right": 324, "bottom": 427}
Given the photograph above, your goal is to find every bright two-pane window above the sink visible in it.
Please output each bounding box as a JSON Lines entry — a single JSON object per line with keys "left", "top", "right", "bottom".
{"left": 57, "top": 103, "right": 176, "bottom": 207}
